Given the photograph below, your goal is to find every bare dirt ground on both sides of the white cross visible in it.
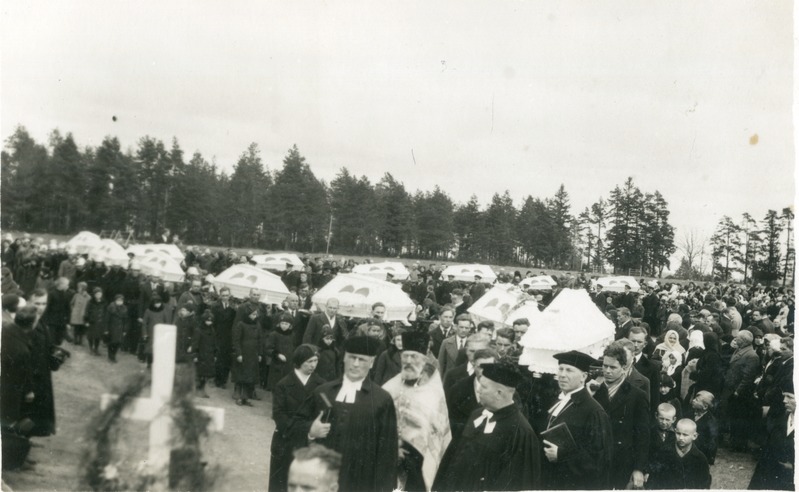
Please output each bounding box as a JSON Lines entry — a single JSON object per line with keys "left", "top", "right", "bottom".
{"left": 3, "top": 344, "right": 275, "bottom": 491}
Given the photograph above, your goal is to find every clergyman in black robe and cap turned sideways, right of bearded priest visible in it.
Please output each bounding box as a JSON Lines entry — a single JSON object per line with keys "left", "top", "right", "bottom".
{"left": 433, "top": 362, "right": 541, "bottom": 490}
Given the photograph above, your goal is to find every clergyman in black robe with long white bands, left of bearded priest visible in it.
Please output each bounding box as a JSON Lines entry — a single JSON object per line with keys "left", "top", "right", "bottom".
{"left": 293, "top": 336, "right": 399, "bottom": 491}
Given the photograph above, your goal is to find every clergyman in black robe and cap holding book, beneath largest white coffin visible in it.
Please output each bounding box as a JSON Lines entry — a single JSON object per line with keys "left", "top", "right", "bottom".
{"left": 542, "top": 350, "right": 612, "bottom": 490}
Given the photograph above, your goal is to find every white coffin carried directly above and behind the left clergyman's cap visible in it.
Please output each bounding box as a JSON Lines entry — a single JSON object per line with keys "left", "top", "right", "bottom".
{"left": 312, "top": 273, "right": 416, "bottom": 321}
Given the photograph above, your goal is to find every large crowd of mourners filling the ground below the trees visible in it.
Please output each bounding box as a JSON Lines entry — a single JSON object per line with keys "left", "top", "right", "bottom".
{"left": 0, "top": 233, "right": 795, "bottom": 490}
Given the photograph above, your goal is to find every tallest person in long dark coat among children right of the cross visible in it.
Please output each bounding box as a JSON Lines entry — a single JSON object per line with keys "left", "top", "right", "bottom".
{"left": 231, "top": 303, "right": 263, "bottom": 406}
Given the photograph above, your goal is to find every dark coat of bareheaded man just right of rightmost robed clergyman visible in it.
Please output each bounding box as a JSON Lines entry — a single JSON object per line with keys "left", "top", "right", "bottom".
{"left": 594, "top": 380, "right": 649, "bottom": 489}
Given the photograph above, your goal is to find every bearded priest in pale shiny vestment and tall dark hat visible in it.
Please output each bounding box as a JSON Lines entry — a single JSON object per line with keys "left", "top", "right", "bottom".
{"left": 383, "top": 332, "right": 452, "bottom": 491}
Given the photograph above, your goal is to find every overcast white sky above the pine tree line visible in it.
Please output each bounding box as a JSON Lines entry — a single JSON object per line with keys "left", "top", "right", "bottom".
{"left": 0, "top": 0, "right": 794, "bottom": 252}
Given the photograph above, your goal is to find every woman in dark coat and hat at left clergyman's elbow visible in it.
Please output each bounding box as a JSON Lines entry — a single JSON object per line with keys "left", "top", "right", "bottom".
{"left": 269, "top": 344, "right": 325, "bottom": 492}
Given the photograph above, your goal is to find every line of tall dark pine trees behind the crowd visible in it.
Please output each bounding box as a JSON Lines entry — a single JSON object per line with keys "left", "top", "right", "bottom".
{"left": 1, "top": 126, "right": 792, "bottom": 278}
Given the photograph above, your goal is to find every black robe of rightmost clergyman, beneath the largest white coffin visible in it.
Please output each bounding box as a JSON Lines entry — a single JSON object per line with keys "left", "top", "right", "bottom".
{"left": 542, "top": 388, "right": 613, "bottom": 490}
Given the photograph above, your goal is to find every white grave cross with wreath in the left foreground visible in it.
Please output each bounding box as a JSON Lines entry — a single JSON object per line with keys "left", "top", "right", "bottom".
{"left": 100, "top": 324, "right": 225, "bottom": 490}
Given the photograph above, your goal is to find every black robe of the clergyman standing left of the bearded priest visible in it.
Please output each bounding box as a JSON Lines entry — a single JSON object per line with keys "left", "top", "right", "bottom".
{"left": 295, "top": 378, "right": 399, "bottom": 492}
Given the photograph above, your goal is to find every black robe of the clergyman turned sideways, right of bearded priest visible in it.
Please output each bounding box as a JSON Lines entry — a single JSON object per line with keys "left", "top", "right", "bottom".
{"left": 433, "top": 404, "right": 542, "bottom": 491}
